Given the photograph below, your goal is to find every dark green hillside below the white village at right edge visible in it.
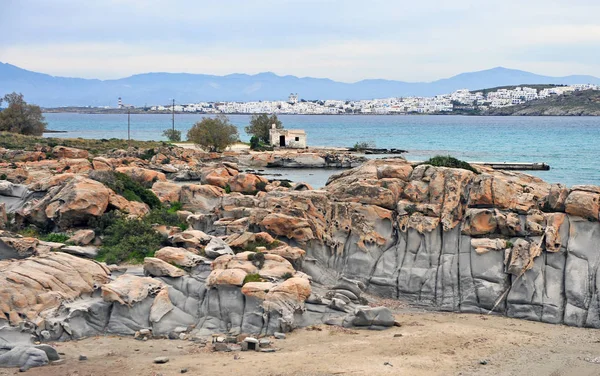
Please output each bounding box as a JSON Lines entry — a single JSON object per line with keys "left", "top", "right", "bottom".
{"left": 483, "top": 90, "right": 600, "bottom": 116}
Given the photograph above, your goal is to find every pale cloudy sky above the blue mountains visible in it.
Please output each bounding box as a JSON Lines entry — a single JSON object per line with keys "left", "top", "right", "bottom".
{"left": 0, "top": 0, "right": 600, "bottom": 82}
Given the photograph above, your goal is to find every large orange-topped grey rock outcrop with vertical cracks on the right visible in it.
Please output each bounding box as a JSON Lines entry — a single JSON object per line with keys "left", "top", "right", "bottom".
{"left": 196, "top": 159, "right": 600, "bottom": 327}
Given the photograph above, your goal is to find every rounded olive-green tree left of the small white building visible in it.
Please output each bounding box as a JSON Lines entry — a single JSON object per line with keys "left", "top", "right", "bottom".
{"left": 187, "top": 115, "right": 239, "bottom": 151}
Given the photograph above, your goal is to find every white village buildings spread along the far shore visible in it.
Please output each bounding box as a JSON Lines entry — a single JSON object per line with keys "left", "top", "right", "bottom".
{"left": 146, "top": 84, "right": 600, "bottom": 115}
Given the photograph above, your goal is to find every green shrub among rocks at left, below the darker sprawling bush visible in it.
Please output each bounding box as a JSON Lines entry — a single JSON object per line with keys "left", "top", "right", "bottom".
{"left": 97, "top": 217, "right": 162, "bottom": 264}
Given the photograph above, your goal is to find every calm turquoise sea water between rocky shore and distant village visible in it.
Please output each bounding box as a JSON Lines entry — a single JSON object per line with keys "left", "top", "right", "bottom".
{"left": 45, "top": 113, "right": 600, "bottom": 185}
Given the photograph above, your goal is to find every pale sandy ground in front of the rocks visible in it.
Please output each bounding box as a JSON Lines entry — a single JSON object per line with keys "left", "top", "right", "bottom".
{"left": 0, "top": 312, "right": 600, "bottom": 376}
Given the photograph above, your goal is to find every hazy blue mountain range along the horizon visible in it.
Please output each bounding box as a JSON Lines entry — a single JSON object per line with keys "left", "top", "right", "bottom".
{"left": 0, "top": 62, "right": 600, "bottom": 107}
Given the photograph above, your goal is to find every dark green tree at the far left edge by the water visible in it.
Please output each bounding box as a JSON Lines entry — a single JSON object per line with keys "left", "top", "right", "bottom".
{"left": 0, "top": 93, "right": 46, "bottom": 136}
